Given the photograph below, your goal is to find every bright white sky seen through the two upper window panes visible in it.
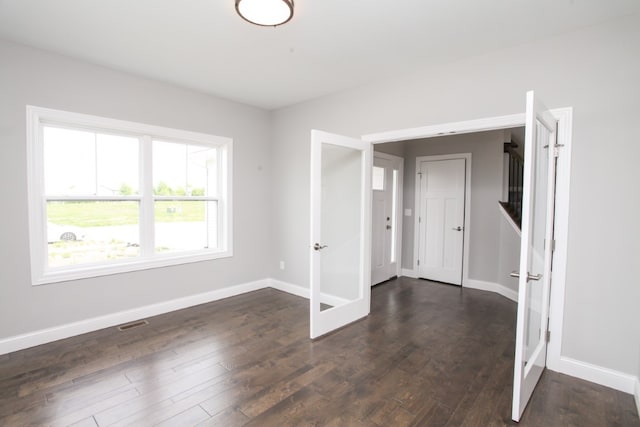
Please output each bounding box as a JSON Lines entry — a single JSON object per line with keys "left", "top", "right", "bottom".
{"left": 43, "top": 126, "right": 217, "bottom": 196}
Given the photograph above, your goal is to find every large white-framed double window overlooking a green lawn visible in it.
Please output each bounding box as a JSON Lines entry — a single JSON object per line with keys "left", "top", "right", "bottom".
{"left": 27, "top": 107, "right": 232, "bottom": 284}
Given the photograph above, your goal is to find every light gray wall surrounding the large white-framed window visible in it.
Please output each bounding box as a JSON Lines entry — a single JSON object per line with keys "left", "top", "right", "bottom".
{"left": 0, "top": 42, "right": 271, "bottom": 339}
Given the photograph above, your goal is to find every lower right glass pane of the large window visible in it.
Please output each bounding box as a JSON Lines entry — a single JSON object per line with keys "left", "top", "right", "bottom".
{"left": 155, "top": 200, "right": 219, "bottom": 253}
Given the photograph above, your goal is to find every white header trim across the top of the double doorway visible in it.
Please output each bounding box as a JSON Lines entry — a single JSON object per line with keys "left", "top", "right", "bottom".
{"left": 362, "top": 113, "right": 524, "bottom": 144}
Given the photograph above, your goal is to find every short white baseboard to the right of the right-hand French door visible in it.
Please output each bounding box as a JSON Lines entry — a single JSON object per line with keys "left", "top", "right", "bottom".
{"left": 551, "top": 358, "right": 638, "bottom": 396}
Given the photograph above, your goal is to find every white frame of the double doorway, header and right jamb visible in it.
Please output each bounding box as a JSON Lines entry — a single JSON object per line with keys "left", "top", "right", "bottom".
{"left": 362, "top": 107, "right": 573, "bottom": 372}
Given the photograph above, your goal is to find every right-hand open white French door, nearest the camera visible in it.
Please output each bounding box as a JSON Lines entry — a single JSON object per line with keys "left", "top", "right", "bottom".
{"left": 512, "top": 92, "right": 557, "bottom": 421}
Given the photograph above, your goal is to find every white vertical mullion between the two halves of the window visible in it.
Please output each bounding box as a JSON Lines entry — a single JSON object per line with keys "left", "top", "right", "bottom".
{"left": 140, "top": 135, "right": 155, "bottom": 257}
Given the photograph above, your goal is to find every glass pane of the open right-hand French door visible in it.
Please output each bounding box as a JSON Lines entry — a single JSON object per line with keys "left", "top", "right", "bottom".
{"left": 524, "top": 122, "right": 550, "bottom": 360}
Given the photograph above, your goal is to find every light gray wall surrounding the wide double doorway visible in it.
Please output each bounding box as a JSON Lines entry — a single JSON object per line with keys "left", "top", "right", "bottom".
{"left": 270, "top": 16, "right": 640, "bottom": 375}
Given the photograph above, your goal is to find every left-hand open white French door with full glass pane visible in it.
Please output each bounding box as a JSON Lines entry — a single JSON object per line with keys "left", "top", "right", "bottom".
{"left": 310, "top": 130, "right": 372, "bottom": 338}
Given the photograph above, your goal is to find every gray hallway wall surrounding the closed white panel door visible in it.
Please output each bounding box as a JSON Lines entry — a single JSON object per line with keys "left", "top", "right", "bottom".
{"left": 402, "top": 131, "right": 503, "bottom": 283}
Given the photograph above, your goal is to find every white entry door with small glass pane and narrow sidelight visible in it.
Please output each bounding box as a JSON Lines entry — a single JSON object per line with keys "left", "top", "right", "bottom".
{"left": 371, "top": 153, "right": 402, "bottom": 286}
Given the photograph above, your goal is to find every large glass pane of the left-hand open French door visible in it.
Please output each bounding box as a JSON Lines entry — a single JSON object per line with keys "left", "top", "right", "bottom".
{"left": 320, "top": 144, "right": 363, "bottom": 310}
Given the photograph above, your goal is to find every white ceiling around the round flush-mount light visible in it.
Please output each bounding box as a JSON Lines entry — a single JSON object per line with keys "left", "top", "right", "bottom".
{"left": 0, "top": 0, "right": 640, "bottom": 109}
